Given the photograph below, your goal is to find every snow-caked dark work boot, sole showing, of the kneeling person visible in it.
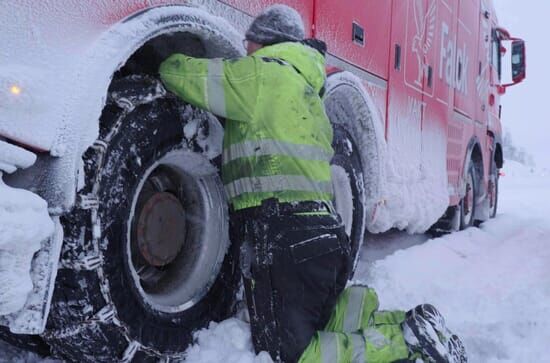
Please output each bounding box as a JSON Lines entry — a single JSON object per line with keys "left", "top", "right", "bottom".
{"left": 402, "top": 304, "right": 467, "bottom": 363}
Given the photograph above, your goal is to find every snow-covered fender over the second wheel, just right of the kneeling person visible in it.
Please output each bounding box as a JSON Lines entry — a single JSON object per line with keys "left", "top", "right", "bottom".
{"left": 324, "top": 71, "right": 391, "bottom": 232}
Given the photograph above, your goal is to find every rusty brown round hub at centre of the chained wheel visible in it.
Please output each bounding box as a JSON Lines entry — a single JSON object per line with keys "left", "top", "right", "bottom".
{"left": 137, "top": 192, "right": 186, "bottom": 267}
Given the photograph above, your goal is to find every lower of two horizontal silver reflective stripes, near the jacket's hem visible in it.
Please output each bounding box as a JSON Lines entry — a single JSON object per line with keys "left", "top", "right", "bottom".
{"left": 225, "top": 175, "right": 332, "bottom": 198}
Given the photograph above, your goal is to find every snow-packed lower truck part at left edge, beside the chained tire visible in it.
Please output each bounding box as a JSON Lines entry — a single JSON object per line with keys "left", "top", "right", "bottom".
{"left": 0, "top": 154, "right": 63, "bottom": 334}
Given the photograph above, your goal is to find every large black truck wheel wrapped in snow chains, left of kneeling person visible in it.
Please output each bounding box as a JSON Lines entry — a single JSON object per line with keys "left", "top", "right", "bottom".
{"left": 43, "top": 78, "right": 239, "bottom": 362}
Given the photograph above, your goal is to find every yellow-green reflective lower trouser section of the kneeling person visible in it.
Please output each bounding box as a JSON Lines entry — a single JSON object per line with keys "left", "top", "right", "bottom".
{"left": 299, "top": 286, "right": 416, "bottom": 363}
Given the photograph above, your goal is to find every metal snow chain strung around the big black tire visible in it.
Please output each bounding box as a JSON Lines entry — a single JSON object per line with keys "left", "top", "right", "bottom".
{"left": 47, "top": 76, "right": 181, "bottom": 363}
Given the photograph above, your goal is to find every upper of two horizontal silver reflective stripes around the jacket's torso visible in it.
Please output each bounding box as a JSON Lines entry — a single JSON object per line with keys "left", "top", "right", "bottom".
{"left": 223, "top": 140, "right": 332, "bottom": 164}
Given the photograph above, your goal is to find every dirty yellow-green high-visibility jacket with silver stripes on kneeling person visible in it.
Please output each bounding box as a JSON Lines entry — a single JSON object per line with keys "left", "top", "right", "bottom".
{"left": 160, "top": 43, "right": 334, "bottom": 210}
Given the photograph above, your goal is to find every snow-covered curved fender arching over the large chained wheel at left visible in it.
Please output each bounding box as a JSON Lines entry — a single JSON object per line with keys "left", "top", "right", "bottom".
{"left": 7, "top": 1, "right": 243, "bottom": 215}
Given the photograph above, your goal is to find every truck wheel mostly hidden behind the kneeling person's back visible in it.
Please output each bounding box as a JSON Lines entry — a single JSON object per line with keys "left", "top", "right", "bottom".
{"left": 331, "top": 124, "right": 365, "bottom": 277}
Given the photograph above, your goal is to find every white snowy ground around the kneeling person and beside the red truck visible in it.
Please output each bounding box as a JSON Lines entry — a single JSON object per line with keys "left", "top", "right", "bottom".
{"left": 0, "top": 163, "right": 550, "bottom": 363}
